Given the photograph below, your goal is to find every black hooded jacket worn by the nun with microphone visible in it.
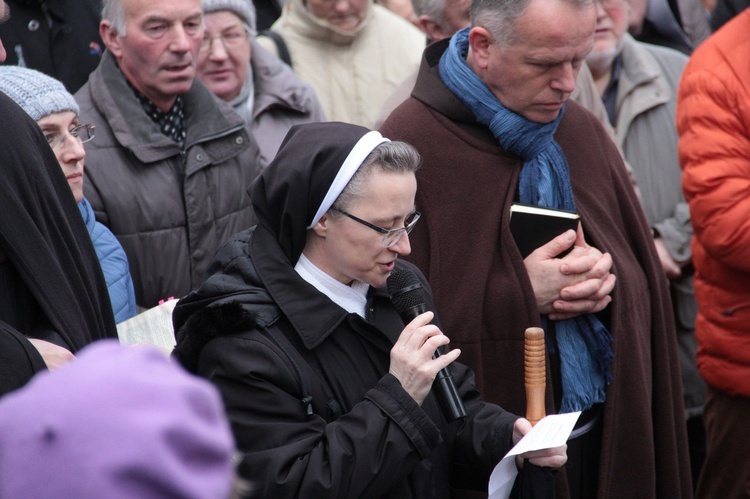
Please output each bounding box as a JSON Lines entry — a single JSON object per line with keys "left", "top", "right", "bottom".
{"left": 173, "top": 226, "right": 516, "bottom": 499}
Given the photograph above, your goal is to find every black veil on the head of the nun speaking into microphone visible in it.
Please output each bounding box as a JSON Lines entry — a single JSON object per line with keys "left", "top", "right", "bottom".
{"left": 248, "top": 122, "right": 370, "bottom": 265}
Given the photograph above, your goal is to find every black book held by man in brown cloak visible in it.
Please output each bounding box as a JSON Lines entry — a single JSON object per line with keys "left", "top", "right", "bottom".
{"left": 510, "top": 203, "right": 581, "bottom": 258}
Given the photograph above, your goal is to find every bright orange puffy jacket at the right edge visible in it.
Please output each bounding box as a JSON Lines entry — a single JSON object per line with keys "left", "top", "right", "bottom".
{"left": 677, "top": 10, "right": 750, "bottom": 397}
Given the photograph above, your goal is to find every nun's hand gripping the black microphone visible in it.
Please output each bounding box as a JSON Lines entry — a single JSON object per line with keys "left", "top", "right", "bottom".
{"left": 388, "top": 312, "right": 461, "bottom": 405}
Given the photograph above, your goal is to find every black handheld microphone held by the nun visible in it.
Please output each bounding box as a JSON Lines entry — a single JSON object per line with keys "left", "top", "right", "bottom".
{"left": 387, "top": 269, "right": 466, "bottom": 421}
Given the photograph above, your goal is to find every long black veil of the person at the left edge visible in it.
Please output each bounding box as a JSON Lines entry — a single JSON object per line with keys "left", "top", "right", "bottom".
{"left": 0, "top": 93, "right": 117, "bottom": 390}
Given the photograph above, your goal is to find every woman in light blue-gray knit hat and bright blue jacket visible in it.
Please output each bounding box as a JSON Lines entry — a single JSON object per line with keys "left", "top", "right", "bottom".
{"left": 0, "top": 66, "right": 136, "bottom": 322}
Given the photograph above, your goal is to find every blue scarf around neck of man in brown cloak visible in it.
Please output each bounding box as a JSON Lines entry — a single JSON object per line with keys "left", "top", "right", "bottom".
{"left": 439, "top": 28, "right": 614, "bottom": 412}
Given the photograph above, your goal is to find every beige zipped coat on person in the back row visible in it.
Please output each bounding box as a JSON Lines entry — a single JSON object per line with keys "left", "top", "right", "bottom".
{"left": 258, "top": 0, "right": 426, "bottom": 128}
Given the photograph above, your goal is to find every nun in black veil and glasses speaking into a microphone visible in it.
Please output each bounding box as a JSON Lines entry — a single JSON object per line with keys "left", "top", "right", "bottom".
{"left": 173, "top": 122, "right": 566, "bottom": 498}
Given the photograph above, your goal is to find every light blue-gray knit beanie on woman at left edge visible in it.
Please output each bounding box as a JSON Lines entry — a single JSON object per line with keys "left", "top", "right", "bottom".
{"left": 0, "top": 66, "right": 79, "bottom": 121}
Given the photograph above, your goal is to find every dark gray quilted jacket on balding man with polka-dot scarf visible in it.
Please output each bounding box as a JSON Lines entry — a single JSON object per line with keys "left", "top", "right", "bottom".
{"left": 76, "top": 52, "right": 260, "bottom": 307}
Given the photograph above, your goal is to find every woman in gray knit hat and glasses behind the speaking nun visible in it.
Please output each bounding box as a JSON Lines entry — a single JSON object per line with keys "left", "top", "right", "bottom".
{"left": 197, "top": 0, "right": 325, "bottom": 165}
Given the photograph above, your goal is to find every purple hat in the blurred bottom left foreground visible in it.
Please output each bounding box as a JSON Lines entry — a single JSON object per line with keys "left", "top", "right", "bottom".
{"left": 0, "top": 340, "right": 234, "bottom": 499}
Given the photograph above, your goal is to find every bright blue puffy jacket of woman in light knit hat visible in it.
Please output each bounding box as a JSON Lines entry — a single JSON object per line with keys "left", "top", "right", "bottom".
{"left": 78, "top": 198, "right": 136, "bottom": 323}
